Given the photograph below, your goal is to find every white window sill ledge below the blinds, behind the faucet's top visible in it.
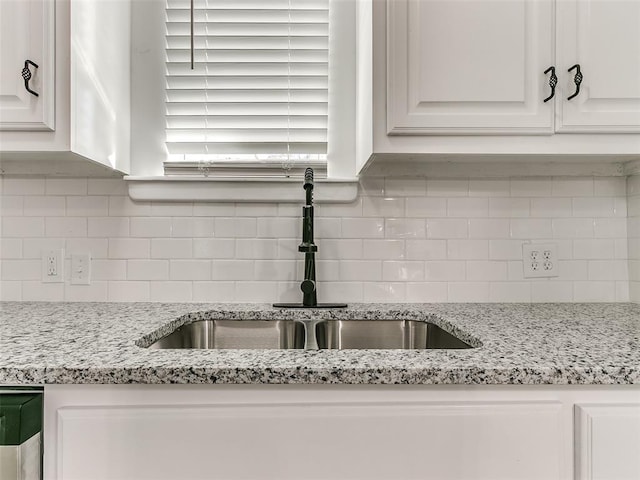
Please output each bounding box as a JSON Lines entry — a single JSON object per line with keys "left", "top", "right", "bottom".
{"left": 124, "top": 176, "right": 358, "bottom": 203}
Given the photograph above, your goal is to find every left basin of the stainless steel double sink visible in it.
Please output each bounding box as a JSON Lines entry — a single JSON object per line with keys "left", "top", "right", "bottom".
{"left": 149, "top": 320, "right": 305, "bottom": 349}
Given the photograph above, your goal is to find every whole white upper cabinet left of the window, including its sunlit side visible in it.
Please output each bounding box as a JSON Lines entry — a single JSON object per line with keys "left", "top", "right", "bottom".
{"left": 0, "top": 0, "right": 131, "bottom": 175}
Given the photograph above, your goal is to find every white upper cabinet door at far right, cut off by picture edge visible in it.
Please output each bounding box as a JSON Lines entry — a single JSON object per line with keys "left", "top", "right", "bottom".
{"left": 557, "top": 0, "right": 640, "bottom": 133}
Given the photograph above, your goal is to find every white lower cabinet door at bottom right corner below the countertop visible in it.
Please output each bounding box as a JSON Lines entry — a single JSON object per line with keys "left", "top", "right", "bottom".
{"left": 575, "top": 403, "right": 640, "bottom": 480}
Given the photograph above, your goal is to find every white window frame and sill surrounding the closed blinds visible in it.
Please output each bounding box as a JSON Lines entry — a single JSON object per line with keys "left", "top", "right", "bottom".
{"left": 125, "top": 0, "right": 361, "bottom": 202}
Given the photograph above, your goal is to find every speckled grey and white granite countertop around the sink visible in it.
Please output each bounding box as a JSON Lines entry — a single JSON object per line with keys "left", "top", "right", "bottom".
{"left": 0, "top": 302, "right": 640, "bottom": 385}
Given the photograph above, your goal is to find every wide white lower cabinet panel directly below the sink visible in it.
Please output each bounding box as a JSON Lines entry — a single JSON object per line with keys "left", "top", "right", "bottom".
{"left": 46, "top": 388, "right": 562, "bottom": 480}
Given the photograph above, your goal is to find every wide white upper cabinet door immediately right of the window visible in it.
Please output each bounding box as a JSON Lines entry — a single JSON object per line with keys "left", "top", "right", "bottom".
{"left": 387, "top": 0, "right": 554, "bottom": 134}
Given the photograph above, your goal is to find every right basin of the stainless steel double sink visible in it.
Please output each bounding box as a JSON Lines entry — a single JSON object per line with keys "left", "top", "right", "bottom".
{"left": 316, "top": 320, "right": 472, "bottom": 349}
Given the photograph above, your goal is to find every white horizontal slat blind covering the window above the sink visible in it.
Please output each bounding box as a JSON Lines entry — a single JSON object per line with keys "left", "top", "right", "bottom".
{"left": 165, "top": 0, "right": 329, "bottom": 174}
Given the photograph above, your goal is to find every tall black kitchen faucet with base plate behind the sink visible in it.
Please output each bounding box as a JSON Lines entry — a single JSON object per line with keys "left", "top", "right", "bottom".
{"left": 273, "top": 168, "right": 347, "bottom": 308}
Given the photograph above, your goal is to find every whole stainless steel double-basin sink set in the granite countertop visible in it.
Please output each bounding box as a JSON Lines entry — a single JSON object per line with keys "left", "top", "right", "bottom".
{"left": 149, "top": 320, "right": 472, "bottom": 350}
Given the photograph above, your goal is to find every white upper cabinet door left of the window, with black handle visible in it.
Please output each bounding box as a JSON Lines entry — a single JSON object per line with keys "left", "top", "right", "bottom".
{"left": 0, "top": 0, "right": 55, "bottom": 130}
